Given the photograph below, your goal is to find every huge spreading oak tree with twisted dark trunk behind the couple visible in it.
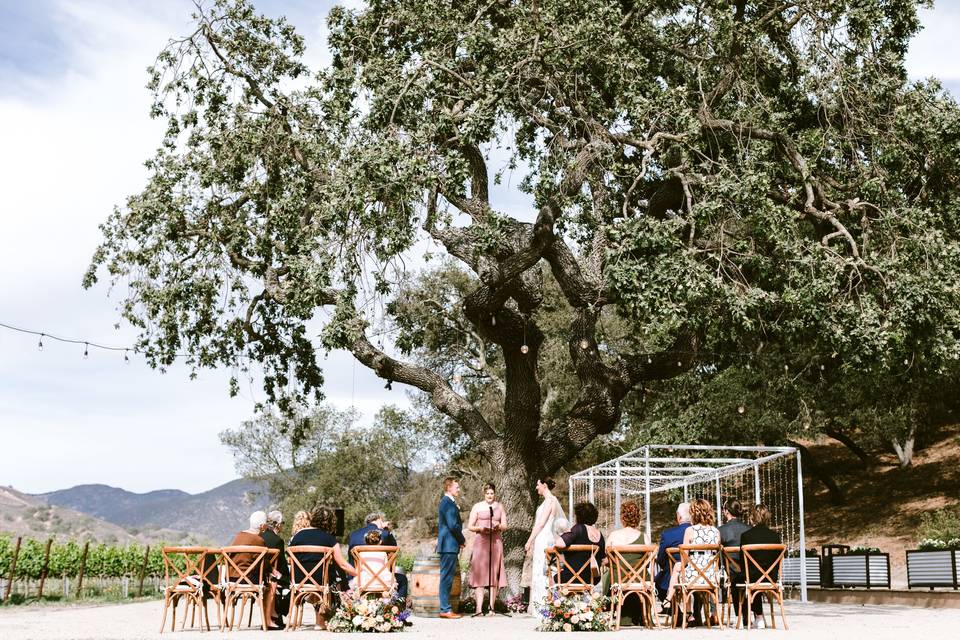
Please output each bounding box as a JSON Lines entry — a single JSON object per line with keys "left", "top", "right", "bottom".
{"left": 87, "top": 0, "right": 960, "bottom": 584}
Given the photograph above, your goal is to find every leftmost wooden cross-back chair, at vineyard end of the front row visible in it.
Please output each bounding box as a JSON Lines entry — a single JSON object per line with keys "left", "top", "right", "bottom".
{"left": 160, "top": 547, "right": 223, "bottom": 633}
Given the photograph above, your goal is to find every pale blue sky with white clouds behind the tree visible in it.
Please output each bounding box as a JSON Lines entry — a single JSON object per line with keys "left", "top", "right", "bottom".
{"left": 0, "top": 0, "right": 960, "bottom": 493}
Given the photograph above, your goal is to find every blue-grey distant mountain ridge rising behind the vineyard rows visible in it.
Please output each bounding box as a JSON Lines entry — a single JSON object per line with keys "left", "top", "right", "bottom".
{"left": 33, "top": 479, "right": 268, "bottom": 544}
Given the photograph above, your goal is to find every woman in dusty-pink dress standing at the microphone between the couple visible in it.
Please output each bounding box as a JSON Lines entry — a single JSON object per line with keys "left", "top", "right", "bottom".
{"left": 467, "top": 483, "right": 507, "bottom": 616}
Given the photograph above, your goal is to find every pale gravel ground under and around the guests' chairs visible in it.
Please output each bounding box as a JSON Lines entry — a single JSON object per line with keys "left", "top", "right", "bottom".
{"left": 0, "top": 602, "right": 960, "bottom": 640}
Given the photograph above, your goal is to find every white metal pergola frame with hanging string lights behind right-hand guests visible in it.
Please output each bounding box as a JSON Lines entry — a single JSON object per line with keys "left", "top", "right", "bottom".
{"left": 568, "top": 444, "right": 807, "bottom": 602}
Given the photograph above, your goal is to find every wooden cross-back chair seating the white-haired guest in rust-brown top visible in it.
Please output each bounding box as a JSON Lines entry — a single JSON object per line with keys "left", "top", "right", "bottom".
{"left": 220, "top": 545, "right": 280, "bottom": 631}
